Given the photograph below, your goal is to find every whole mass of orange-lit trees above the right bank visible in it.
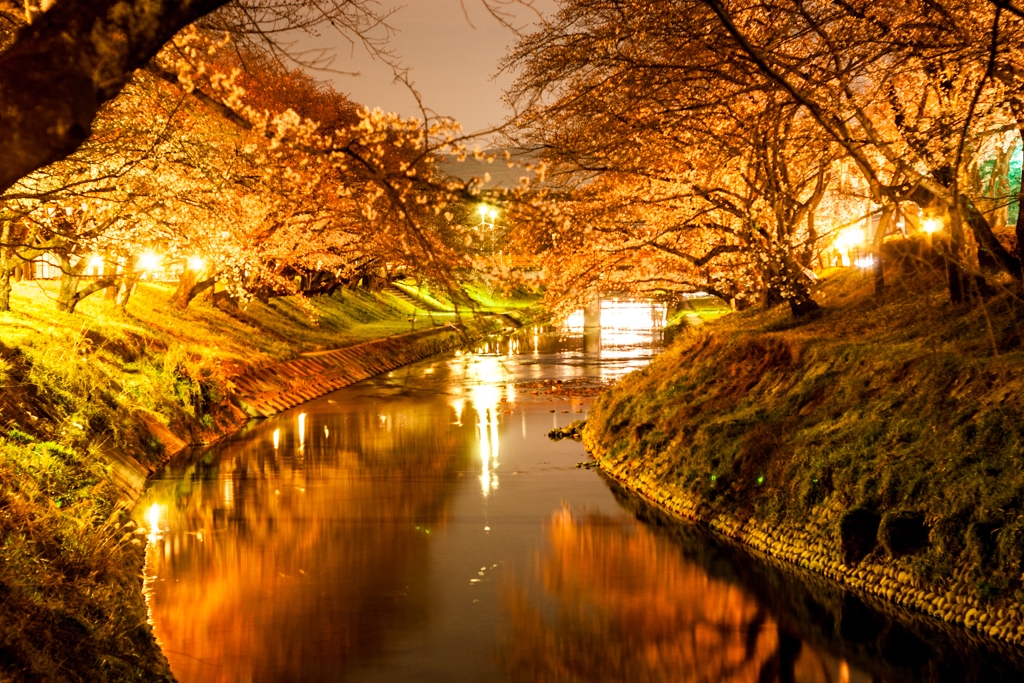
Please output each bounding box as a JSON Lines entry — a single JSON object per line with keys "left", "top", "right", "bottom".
{"left": 507, "top": 0, "right": 1024, "bottom": 312}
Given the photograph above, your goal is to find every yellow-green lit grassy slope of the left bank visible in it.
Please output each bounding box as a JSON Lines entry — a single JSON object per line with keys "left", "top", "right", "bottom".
{"left": 0, "top": 282, "right": 528, "bottom": 681}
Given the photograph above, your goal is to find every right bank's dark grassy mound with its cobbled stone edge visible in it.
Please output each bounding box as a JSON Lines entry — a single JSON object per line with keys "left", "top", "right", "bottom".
{"left": 584, "top": 269, "right": 1024, "bottom": 642}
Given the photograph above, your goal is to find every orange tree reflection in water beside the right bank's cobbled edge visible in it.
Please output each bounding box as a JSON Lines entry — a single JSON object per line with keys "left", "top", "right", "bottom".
{"left": 506, "top": 510, "right": 871, "bottom": 683}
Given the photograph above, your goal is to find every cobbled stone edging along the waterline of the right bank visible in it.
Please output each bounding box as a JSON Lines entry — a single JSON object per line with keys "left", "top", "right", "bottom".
{"left": 585, "top": 456, "right": 1024, "bottom": 655}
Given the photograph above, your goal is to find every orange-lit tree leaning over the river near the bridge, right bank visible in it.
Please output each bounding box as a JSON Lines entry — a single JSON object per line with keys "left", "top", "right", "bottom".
{"left": 508, "top": 2, "right": 837, "bottom": 315}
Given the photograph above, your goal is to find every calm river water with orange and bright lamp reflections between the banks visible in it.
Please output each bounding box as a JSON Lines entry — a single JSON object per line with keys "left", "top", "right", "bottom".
{"left": 137, "top": 302, "right": 1024, "bottom": 683}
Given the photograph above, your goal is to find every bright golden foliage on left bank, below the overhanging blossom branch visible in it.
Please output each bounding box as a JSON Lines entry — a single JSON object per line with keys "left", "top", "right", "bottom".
{"left": 0, "top": 46, "right": 462, "bottom": 309}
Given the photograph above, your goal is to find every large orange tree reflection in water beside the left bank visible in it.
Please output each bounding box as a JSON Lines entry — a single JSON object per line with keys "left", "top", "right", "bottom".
{"left": 136, "top": 400, "right": 476, "bottom": 681}
